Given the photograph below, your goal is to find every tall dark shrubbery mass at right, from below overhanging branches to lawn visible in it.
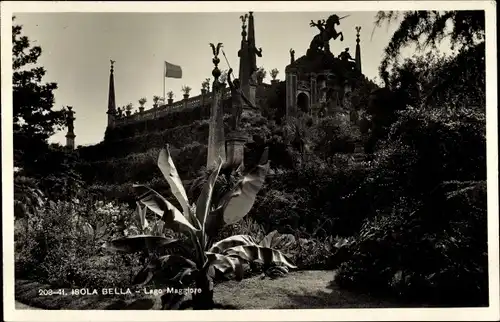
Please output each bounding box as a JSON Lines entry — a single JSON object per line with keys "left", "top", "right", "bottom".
{"left": 336, "top": 102, "right": 488, "bottom": 305}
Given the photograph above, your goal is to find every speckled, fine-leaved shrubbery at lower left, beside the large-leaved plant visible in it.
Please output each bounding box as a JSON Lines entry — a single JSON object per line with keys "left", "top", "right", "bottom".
{"left": 15, "top": 200, "right": 139, "bottom": 287}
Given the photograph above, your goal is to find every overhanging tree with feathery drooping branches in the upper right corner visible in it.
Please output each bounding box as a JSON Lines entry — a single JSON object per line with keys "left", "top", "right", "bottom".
{"left": 368, "top": 11, "right": 485, "bottom": 150}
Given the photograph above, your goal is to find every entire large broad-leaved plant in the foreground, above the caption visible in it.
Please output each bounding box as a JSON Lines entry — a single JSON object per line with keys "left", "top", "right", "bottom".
{"left": 105, "top": 146, "right": 296, "bottom": 309}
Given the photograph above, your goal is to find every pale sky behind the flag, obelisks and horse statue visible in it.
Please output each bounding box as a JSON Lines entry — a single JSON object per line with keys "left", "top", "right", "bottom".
{"left": 16, "top": 11, "right": 408, "bottom": 145}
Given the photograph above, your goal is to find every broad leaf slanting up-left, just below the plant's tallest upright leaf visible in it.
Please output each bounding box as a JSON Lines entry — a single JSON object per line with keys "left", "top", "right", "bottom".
{"left": 134, "top": 185, "right": 199, "bottom": 232}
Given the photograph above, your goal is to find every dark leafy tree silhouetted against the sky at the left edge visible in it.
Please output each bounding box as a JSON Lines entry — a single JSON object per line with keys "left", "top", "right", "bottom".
{"left": 12, "top": 17, "right": 64, "bottom": 167}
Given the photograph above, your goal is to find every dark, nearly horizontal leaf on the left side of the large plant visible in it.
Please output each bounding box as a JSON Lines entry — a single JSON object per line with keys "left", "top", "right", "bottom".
{"left": 103, "top": 235, "right": 178, "bottom": 253}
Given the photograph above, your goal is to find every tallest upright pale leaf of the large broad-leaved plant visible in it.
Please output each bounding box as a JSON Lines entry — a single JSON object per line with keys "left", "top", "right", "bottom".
{"left": 158, "top": 145, "right": 189, "bottom": 217}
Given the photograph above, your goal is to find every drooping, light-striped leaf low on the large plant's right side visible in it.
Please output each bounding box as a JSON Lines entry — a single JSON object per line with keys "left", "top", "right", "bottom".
{"left": 224, "top": 245, "right": 297, "bottom": 268}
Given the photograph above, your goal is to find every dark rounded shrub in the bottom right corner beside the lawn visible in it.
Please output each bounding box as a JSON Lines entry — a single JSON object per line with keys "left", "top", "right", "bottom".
{"left": 336, "top": 182, "right": 488, "bottom": 305}
